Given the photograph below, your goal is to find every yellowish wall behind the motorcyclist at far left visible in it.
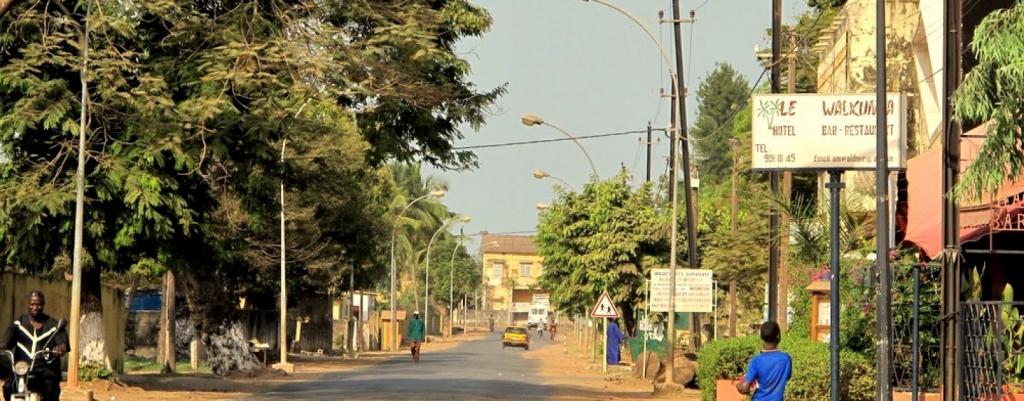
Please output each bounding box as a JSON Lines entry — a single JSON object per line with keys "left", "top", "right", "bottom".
{"left": 0, "top": 273, "right": 125, "bottom": 371}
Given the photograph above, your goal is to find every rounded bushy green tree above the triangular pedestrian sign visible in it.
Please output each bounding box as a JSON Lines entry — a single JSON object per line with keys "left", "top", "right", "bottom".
{"left": 537, "top": 170, "right": 669, "bottom": 328}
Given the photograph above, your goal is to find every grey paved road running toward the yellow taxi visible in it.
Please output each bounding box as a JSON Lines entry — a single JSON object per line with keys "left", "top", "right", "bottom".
{"left": 241, "top": 332, "right": 566, "bottom": 401}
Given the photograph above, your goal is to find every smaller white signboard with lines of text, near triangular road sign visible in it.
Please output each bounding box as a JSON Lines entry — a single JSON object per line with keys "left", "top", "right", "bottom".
{"left": 650, "top": 269, "right": 715, "bottom": 313}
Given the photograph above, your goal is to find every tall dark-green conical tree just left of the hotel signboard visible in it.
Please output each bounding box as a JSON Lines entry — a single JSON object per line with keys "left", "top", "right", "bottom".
{"left": 689, "top": 63, "right": 750, "bottom": 184}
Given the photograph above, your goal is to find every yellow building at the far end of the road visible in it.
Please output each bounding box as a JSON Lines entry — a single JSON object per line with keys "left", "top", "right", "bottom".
{"left": 480, "top": 234, "right": 546, "bottom": 323}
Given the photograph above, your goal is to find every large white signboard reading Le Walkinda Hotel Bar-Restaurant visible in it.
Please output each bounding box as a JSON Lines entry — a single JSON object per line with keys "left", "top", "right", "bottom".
{"left": 751, "top": 93, "right": 906, "bottom": 171}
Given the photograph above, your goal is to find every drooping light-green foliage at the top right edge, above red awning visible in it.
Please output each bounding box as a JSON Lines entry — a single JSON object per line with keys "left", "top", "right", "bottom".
{"left": 953, "top": 1, "right": 1024, "bottom": 197}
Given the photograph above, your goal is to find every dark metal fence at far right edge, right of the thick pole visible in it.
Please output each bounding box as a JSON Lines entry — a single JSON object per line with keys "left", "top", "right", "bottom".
{"left": 961, "top": 301, "right": 1024, "bottom": 401}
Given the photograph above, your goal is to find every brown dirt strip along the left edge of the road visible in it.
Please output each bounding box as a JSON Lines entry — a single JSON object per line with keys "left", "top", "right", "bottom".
{"left": 60, "top": 332, "right": 485, "bottom": 401}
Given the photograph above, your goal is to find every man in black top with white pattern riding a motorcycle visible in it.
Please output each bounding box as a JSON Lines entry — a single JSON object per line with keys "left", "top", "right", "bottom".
{"left": 0, "top": 291, "right": 70, "bottom": 401}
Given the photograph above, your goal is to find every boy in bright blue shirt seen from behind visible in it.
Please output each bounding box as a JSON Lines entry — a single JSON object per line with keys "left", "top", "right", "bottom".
{"left": 736, "top": 321, "right": 793, "bottom": 401}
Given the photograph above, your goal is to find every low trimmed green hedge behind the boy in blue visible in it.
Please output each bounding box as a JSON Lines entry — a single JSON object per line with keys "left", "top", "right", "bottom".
{"left": 697, "top": 337, "right": 874, "bottom": 401}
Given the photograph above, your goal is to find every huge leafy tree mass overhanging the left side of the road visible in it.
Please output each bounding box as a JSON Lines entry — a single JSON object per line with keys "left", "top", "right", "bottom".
{"left": 0, "top": 0, "right": 503, "bottom": 372}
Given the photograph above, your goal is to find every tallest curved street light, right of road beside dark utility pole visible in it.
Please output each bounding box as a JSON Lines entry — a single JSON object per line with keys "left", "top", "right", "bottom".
{"left": 583, "top": 0, "right": 696, "bottom": 383}
